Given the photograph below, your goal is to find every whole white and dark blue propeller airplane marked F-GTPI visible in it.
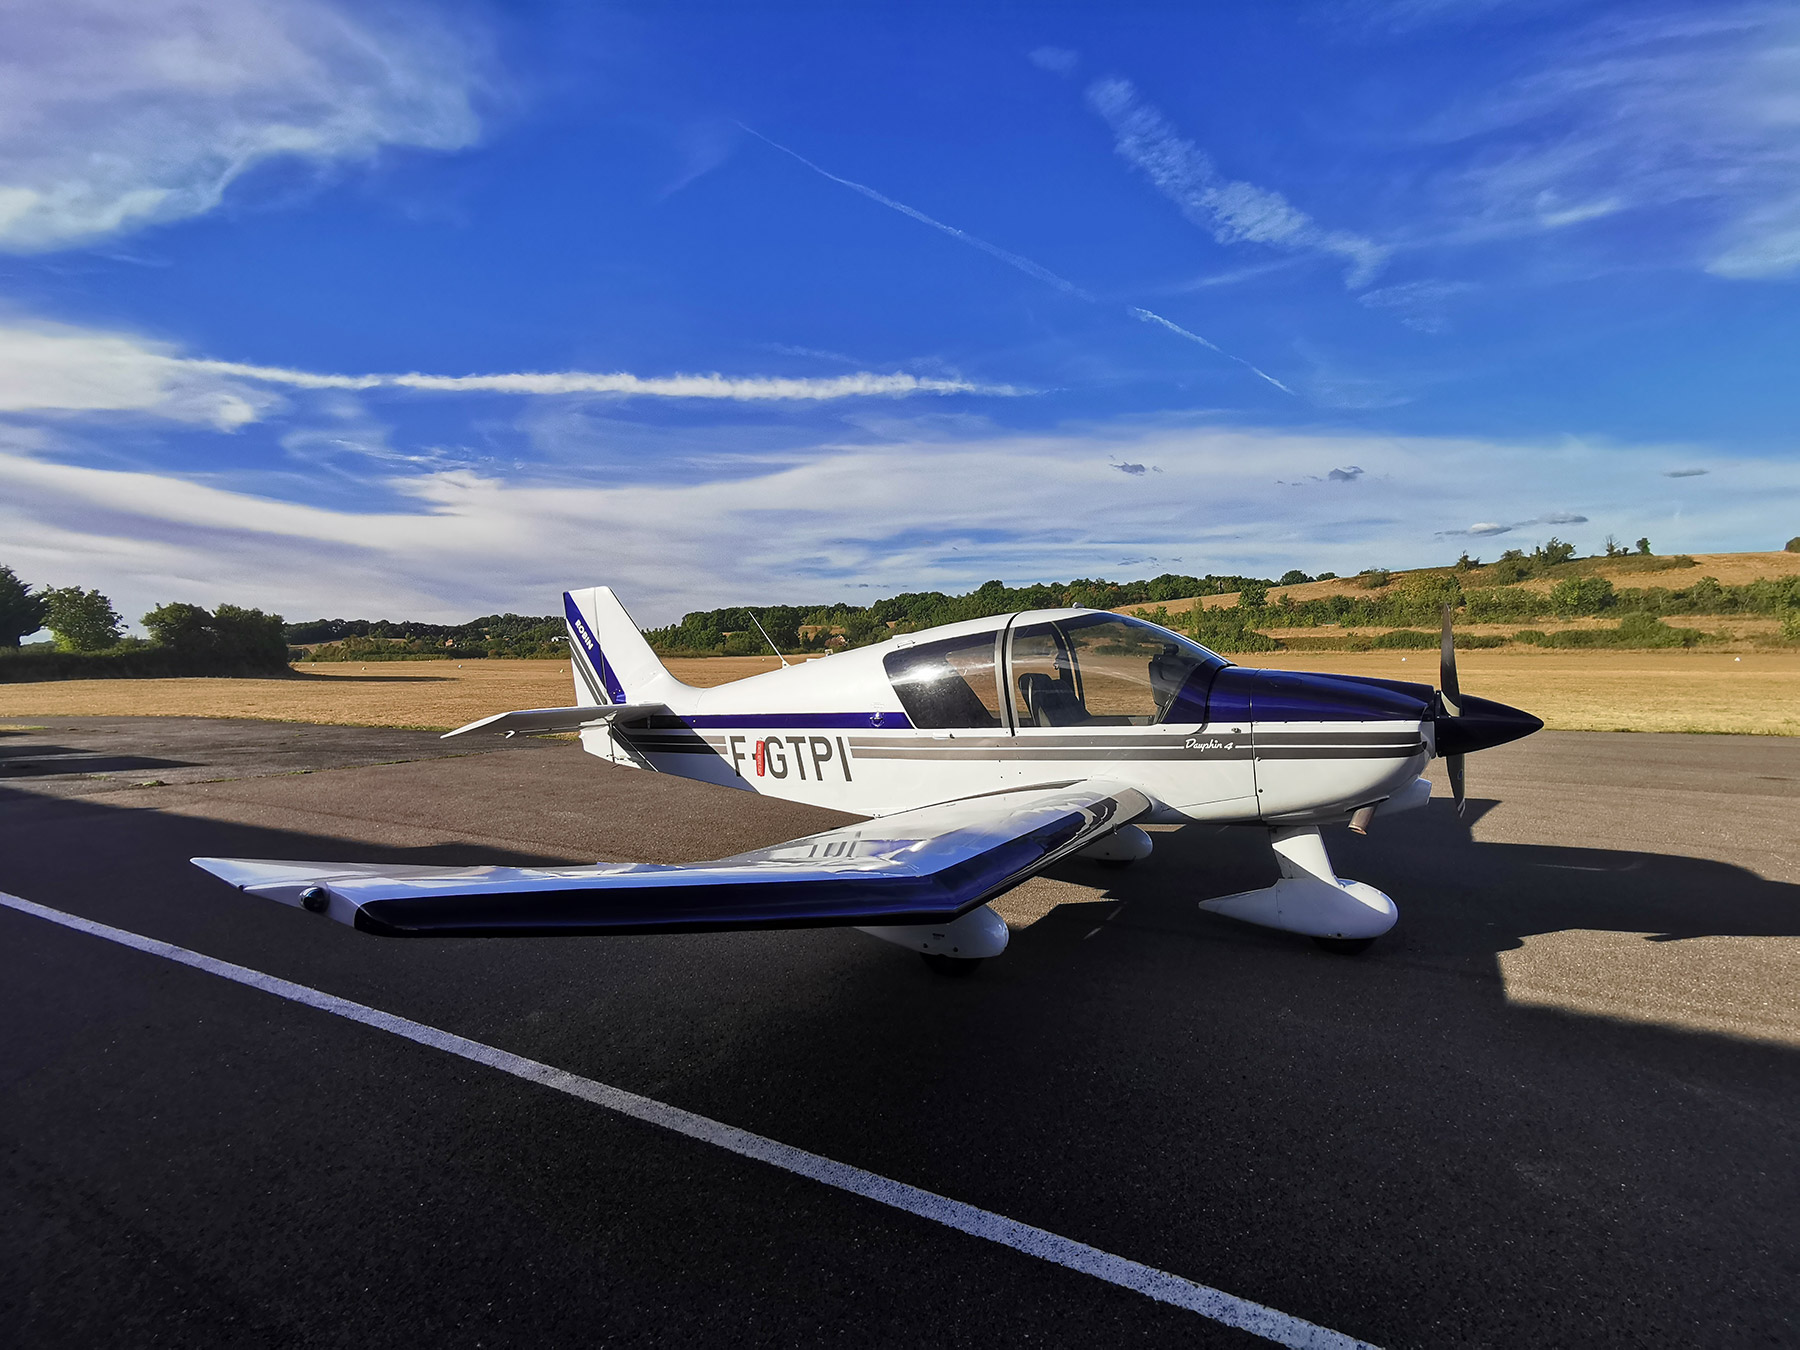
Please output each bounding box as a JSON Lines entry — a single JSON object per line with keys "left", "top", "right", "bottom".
{"left": 194, "top": 587, "right": 1543, "bottom": 974}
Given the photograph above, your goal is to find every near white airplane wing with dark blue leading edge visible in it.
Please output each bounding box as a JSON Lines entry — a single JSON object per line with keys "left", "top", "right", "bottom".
{"left": 194, "top": 781, "right": 1150, "bottom": 938}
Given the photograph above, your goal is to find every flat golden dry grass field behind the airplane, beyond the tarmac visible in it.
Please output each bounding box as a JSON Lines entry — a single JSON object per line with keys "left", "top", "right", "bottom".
{"left": 0, "top": 648, "right": 1800, "bottom": 736}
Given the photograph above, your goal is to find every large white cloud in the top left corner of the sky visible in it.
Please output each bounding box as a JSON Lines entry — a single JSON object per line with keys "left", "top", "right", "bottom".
{"left": 0, "top": 0, "right": 481, "bottom": 252}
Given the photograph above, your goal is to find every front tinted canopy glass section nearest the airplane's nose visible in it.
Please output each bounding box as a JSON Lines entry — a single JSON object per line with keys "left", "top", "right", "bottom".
{"left": 1012, "top": 614, "right": 1229, "bottom": 727}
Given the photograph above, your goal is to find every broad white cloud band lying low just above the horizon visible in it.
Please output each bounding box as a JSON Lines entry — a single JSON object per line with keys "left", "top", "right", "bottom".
{"left": 0, "top": 423, "right": 1800, "bottom": 623}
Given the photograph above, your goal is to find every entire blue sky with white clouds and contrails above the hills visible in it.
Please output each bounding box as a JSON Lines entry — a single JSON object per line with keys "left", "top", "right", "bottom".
{"left": 0, "top": 0, "right": 1800, "bottom": 623}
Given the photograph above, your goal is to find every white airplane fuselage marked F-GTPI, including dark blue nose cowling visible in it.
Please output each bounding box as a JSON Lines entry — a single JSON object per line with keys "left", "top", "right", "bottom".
{"left": 581, "top": 608, "right": 1438, "bottom": 823}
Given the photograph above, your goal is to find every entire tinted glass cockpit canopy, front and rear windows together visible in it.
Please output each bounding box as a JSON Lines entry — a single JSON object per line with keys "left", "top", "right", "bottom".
{"left": 882, "top": 612, "right": 1229, "bottom": 729}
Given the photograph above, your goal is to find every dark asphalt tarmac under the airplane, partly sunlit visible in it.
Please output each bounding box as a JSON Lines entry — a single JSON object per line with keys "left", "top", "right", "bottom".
{"left": 0, "top": 718, "right": 1800, "bottom": 1346}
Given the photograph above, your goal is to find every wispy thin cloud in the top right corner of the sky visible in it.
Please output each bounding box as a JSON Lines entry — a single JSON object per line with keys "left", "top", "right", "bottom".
{"left": 1429, "top": 0, "right": 1800, "bottom": 281}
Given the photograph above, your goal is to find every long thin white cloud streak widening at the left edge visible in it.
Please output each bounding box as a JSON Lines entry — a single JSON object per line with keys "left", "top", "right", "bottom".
{"left": 0, "top": 324, "right": 1026, "bottom": 430}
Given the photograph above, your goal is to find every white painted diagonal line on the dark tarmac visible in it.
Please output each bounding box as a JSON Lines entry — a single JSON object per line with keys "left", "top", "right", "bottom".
{"left": 0, "top": 891, "right": 1375, "bottom": 1350}
